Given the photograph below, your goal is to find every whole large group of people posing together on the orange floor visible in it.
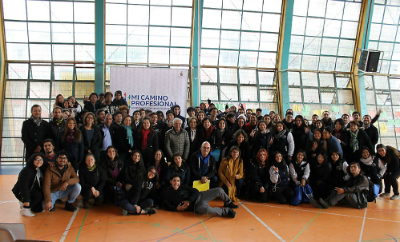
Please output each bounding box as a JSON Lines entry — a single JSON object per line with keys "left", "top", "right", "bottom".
{"left": 13, "top": 91, "right": 400, "bottom": 218}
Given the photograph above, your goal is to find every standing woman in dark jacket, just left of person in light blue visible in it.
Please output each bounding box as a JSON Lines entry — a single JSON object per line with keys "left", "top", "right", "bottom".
{"left": 79, "top": 112, "right": 103, "bottom": 165}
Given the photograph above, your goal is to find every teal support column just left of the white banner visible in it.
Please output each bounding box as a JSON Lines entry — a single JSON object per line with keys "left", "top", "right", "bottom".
{"left": 94, "top": 0, "right": 105, "bottom": 93}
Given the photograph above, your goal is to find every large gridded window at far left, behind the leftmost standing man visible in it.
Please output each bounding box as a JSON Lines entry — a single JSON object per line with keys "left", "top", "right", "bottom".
{"left": 1, "top": 0, "right": 95, "bottom": 162}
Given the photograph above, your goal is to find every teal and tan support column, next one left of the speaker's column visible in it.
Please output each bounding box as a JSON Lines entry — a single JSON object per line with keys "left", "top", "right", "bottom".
{"left": 277, "top": 0, "right": 294, "bottom": 118}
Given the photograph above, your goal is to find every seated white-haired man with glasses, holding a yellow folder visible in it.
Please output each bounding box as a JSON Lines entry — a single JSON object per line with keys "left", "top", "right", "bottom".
{"left": 188, "top": 141, "right": 218, "bottom": 188}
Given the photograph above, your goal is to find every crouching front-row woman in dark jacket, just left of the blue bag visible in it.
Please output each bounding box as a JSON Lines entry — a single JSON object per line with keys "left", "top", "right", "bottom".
{"left": 269, "top": 152, "right": 294, "bottom": 204}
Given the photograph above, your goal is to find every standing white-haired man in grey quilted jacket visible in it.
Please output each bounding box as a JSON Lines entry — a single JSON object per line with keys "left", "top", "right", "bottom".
{"left": 164, "top": 118, "right": 190, "bottom": 161}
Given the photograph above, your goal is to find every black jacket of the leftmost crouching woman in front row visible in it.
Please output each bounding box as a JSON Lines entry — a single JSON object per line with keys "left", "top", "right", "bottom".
{"left": 12, "top": 153, "right": 44, "bottom": 202}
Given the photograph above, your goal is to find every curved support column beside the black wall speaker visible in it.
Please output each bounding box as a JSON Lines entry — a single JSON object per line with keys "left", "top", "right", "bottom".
{"left": 351, "top": 0, "right": 375, "bottom": 116}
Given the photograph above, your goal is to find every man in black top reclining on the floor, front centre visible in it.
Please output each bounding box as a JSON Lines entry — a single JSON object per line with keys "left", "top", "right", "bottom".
{"left": 163, "top": 173, "right": 239, "bottom": 218}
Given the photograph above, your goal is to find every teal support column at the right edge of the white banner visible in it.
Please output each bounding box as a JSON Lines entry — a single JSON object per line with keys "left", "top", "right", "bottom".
{"left": 189, "top": 0, "right": 204, "bottom": 107}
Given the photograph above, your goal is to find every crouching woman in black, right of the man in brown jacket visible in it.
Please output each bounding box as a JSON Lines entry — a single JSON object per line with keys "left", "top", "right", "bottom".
{"left": 79, "top": 154, "right": 107, "bottom": 208}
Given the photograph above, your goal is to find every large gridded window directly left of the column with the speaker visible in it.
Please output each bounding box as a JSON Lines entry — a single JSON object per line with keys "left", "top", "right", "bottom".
{"left": 289, "top": 0, "right": 361, "bottom": 118}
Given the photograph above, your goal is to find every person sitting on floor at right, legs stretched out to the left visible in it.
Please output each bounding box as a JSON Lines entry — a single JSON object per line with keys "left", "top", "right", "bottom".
{"left": 310, "top": 162, "right": 369, "bottom": 209}
